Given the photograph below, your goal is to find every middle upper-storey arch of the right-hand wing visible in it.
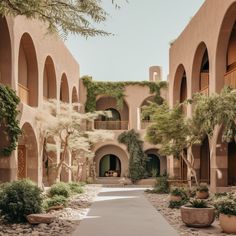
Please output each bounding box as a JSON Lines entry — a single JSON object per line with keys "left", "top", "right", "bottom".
{"left": 192, "top": 42, "right": 209, "bottom": 95}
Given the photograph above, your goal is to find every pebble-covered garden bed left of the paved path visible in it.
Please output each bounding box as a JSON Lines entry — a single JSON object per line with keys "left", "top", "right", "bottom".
{"left": 0, "top": 185, "right": 100, "bottom": 236}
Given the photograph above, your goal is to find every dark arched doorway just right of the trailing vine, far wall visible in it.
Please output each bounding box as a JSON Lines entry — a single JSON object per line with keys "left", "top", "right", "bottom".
{"left": 146, "top": 153, "right": 160, "bottom": 177}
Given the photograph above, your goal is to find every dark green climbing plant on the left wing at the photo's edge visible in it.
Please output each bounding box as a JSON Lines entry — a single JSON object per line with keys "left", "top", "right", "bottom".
{"left": 0, "top": 84, "right": 21, "bottom": 156}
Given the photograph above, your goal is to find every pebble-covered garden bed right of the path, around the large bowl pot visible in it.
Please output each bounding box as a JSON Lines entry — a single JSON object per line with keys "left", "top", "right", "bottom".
{"left": 145, "top": 193, "right": 227, "bottom": 236}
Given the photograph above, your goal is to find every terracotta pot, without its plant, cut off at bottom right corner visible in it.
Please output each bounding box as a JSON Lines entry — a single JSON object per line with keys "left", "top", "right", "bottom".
{"left": 219, "top": 213, "right": 236, "bottom": 234}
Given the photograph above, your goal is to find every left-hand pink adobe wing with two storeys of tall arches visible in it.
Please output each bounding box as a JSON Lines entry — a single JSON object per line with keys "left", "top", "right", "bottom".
{"left": 0, "top": 17, "right": 80, "bottom": 186}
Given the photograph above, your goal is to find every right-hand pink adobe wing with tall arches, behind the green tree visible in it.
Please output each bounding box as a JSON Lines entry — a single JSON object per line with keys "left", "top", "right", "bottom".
{"left": 169, "top": 0, "right": 236, "bottom": 191}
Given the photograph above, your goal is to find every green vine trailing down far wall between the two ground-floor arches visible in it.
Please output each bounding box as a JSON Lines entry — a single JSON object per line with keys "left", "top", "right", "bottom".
{"left": 118, "top": 129, "right": 147, "bottom": 182}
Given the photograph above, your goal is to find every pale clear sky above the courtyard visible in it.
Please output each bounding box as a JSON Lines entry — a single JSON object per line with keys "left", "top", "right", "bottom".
{"left": 66, "top": 0, "right": 204, "bottom": 81}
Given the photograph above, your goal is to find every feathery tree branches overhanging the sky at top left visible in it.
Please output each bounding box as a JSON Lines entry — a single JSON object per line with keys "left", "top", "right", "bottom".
{"left": 0, "top": 0, "right": 121, "bottom": 37}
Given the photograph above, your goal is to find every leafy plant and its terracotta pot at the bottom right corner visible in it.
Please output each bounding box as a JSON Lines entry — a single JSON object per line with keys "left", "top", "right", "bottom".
{"left": 215, "top": 196, "right": 236, "bottom": 234}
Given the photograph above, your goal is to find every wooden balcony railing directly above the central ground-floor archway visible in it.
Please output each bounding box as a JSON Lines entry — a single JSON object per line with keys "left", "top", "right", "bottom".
{"left": 94, "top": 120, "right": 129, "bottom": 130}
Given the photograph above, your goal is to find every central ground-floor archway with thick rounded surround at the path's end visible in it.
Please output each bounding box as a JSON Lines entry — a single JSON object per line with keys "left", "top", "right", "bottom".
{"left": 94, "top": 144, "right": 129, "bottom": 177}
